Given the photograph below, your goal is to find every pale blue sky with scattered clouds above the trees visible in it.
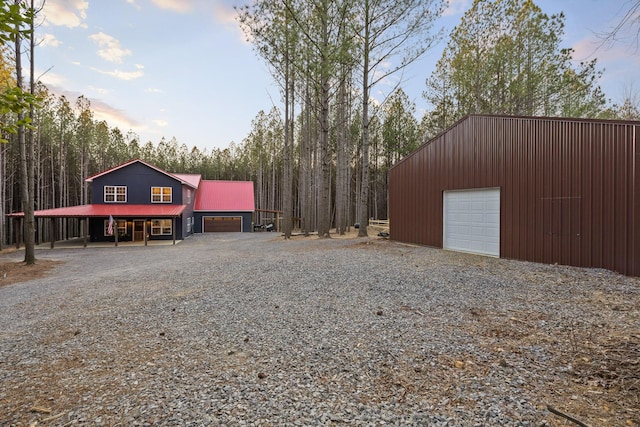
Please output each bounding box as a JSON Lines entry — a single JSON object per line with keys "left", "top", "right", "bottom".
{"left": 35, "top": 0, "right": 640, "bottom": 152}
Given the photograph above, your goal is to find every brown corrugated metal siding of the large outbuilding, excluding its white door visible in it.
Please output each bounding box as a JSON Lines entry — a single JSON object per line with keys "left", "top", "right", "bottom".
{"left": 389, "top": 116, "right": 640, "bottom": 276}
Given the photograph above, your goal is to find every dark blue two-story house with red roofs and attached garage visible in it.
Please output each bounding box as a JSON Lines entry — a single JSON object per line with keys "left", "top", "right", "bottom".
{"left": 8, "top": 159, "right": 255, "bottom": 247}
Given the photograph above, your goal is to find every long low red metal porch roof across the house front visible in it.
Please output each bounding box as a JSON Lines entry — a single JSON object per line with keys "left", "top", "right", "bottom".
{"left": 7, "top": 204, "right": 187, "bottom": 218}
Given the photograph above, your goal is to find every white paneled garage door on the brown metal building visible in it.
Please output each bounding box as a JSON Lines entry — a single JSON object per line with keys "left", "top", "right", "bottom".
{"left": 444, "top": 188, "right": 500, "bottom": 257}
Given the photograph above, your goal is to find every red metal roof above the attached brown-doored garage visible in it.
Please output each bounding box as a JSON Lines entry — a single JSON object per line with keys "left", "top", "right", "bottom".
{"left": 195, "top": 180, "right": 255, "bottom": 212}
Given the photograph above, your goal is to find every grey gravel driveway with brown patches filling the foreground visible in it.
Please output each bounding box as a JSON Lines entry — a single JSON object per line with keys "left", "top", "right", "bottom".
{"left": 0, "top": 233, "right": 640, "bottom": 426}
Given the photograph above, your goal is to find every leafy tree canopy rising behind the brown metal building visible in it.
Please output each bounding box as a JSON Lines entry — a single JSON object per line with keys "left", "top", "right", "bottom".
{"left": 424, "top": 0, "right": 606, "bottom": 137}
